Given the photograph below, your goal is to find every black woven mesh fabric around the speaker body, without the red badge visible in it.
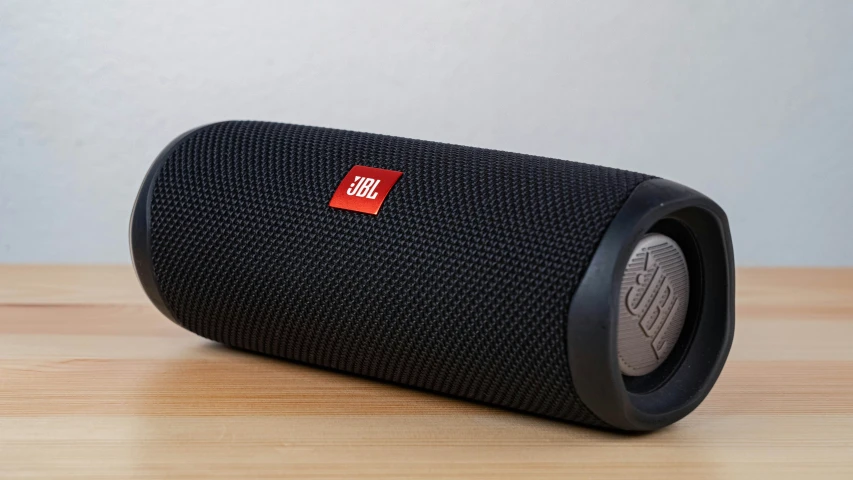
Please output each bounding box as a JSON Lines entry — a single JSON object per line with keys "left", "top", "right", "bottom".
{"left": 149, "top": 122, "right": 651, "bottom": 426}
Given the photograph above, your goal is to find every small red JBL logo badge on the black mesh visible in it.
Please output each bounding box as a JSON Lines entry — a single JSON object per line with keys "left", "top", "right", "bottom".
{"left": 329, "top": 165, "right": 403, "bottom": 215}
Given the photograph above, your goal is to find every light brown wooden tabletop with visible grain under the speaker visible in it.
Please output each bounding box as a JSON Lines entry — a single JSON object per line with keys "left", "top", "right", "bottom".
{"left": 0, "top": 266, "right": 853, "bottom": 480}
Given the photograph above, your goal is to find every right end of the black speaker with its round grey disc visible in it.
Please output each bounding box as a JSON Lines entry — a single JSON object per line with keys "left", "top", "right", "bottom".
{"left": 567, "top": 179, "right": 734, "bottom": 431}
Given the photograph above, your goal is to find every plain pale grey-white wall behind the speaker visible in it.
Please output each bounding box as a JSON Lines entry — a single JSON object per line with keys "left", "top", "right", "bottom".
{"left": 0, "top": 0, "right": 853, "bottom": 265}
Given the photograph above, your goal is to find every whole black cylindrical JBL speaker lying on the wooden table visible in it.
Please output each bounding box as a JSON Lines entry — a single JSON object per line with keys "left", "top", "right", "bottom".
{"left": 130, "top": 121, "right": 734, "bottom": 431}
